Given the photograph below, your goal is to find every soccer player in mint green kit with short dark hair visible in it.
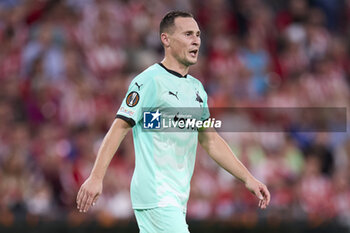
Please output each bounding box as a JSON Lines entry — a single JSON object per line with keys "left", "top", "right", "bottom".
{"left": 77, "top": 11, "right": 270, "bottom": 233}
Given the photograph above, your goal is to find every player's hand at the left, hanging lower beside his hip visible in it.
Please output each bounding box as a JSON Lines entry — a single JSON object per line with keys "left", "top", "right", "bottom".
{"left": 77, "top": 176, "right": 102, "bottom": 212}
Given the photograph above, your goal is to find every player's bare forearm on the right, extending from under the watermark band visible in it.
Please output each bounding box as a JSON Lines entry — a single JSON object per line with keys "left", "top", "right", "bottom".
{"left": 201, "top": 132, "right": 253, "bottom": 183}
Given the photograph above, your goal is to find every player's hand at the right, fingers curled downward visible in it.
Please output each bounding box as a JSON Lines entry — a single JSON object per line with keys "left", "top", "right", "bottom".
{"left": 245, "top": 177, "right": 270, "bottom": 209}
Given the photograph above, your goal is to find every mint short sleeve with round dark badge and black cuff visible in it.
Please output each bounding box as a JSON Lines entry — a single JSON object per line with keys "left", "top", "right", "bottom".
{"left": 116, "top": 76, "right": 157, "bottom": 127}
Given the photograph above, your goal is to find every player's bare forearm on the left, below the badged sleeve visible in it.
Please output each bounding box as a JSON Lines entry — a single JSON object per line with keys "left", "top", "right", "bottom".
{"left": 90, "top": 119, "right": 130, "bottom": 180}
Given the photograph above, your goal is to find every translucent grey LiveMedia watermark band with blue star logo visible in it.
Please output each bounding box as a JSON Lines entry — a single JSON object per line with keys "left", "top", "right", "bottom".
{"left": 143, "top": 107, "right": 347, "bottom": 132}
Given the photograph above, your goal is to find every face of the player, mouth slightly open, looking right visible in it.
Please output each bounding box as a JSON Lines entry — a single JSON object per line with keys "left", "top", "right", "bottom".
{"left": 165, "top": 17, "right": 201, "bottom": 66}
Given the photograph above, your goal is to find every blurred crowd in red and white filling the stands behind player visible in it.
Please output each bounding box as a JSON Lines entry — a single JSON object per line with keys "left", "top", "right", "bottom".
{"left": 0, "top": 0, "right": 350, "bottom": 229}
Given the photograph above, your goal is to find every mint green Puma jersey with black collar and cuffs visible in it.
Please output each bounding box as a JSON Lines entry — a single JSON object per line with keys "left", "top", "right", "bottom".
{"left": 117, "top": 63, "right": 209, "bottom": 210}
